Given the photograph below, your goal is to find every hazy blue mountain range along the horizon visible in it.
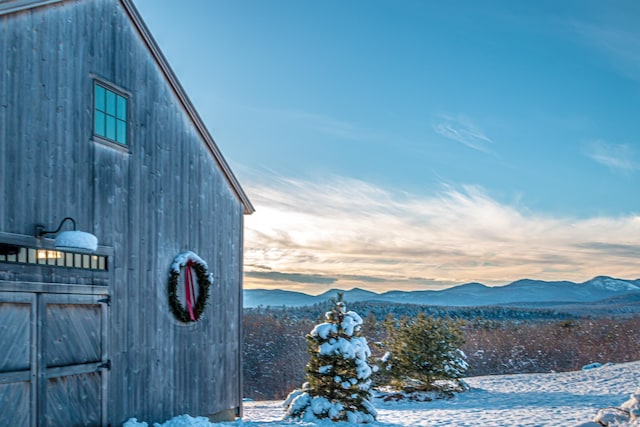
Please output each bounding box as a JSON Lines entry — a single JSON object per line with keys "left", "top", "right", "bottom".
{"left": 244, "top": 276, "right": 640, "bottom": 307}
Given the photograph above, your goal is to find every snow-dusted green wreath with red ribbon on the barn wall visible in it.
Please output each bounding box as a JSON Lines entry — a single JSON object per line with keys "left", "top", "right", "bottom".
{"left": 169, "top": 251, "right": 213, "bottom": 323}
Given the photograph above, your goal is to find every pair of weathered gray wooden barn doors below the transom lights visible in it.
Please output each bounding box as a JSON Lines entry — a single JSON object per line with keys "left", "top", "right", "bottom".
{"left": 0, "top": 292, "right": 109, "bottom": 427}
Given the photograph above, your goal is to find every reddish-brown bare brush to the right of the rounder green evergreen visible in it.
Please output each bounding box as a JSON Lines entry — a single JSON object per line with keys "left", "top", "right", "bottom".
{"left": 463, "top": 317, "right": 640, "bottom": 376}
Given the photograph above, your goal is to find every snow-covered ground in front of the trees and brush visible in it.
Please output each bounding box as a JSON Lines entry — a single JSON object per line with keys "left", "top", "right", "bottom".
{"left": 125, "top": 361, "right": 640, "bottom": 427}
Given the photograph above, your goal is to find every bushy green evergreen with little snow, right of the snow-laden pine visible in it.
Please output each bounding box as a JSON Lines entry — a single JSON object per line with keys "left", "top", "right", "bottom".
{"left": 380, "top": 313, "right": 469, "bottom": 392}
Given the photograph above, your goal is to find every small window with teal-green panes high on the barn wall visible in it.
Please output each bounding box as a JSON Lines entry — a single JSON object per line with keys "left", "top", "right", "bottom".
{"left": 93, "top": 82, "right": 127, "bottom": 145}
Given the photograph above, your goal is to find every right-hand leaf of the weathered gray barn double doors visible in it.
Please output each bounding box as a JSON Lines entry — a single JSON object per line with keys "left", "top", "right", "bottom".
{"left": 38, "top": 294, "right": 107, "bottom": 426}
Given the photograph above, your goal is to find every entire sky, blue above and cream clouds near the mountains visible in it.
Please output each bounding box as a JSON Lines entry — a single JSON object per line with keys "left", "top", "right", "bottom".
{"left": 135, "top": 0, "right": 640, "bottom": 293}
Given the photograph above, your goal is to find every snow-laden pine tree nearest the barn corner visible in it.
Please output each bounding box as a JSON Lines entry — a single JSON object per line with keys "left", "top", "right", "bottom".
{"left": 285, "top": 293, "right": 377, "bottom": 423}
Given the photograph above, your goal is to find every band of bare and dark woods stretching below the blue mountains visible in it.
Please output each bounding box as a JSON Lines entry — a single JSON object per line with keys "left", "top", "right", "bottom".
{"left": 243, "top": 303, "right": 640, "bottom": 400}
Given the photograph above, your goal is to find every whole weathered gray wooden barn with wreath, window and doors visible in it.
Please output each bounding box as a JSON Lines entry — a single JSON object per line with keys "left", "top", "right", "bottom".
{"left": 0, "top": 0, "right": 253, "bottom": 426}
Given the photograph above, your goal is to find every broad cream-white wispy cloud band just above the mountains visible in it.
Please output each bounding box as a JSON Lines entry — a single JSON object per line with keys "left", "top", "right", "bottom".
{"left": 245, "top": 172, "right": 640, "bottom": 292}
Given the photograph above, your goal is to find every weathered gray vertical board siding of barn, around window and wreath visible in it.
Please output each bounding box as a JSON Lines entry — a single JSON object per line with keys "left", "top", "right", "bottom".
{"left": 0, "top": 0, "right": 244, "bottom": 425}
